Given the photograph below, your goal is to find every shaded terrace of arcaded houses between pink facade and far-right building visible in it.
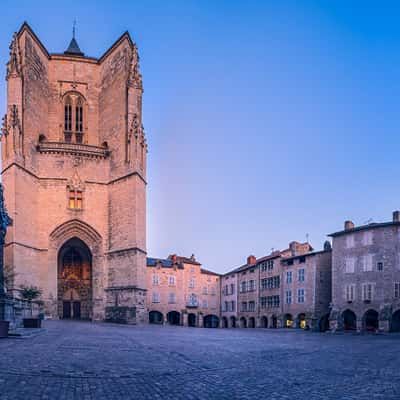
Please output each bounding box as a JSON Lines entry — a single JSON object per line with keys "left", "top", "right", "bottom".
{"left": 221, "top": 241, "right": 331, "bottom": 331}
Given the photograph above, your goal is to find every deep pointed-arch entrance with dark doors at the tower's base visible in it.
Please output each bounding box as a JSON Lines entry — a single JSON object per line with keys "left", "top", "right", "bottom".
{"left": 57, "top": 237, "right": 93, "bottom": 319}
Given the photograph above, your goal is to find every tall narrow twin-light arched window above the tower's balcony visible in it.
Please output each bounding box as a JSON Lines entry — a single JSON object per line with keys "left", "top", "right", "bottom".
{"left": 64, "top": 93, "right": 84, "bottom": 143}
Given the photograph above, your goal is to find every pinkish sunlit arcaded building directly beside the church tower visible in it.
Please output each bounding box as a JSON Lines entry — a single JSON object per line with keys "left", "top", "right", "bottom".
{"left": 147, "top": 255, "right": 220, "bottom": 328}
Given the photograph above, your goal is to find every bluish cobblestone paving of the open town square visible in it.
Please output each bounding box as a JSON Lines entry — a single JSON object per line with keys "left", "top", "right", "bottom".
{"left": 0, "top": 321, "right": 400, "bottom": 400}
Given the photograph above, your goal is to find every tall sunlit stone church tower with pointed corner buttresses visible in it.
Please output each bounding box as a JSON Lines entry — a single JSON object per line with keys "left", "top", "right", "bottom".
{"left": 1, "top": 23, "right": 147, "bottom": 323}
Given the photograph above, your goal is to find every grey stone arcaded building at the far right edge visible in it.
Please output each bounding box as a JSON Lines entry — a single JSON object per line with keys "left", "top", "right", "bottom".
{"left": 330, "top": 211, "right": 400, "bottom": 332}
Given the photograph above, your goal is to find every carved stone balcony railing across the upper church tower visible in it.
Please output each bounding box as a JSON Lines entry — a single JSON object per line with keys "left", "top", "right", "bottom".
{"left": 37, "top": 141, "right": 110, "bottom": 158}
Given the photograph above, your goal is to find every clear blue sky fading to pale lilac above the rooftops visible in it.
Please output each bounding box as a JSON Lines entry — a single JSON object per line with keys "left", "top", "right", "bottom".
{"left": 0, "top": 0, "right": 400, "bottom": 272}
